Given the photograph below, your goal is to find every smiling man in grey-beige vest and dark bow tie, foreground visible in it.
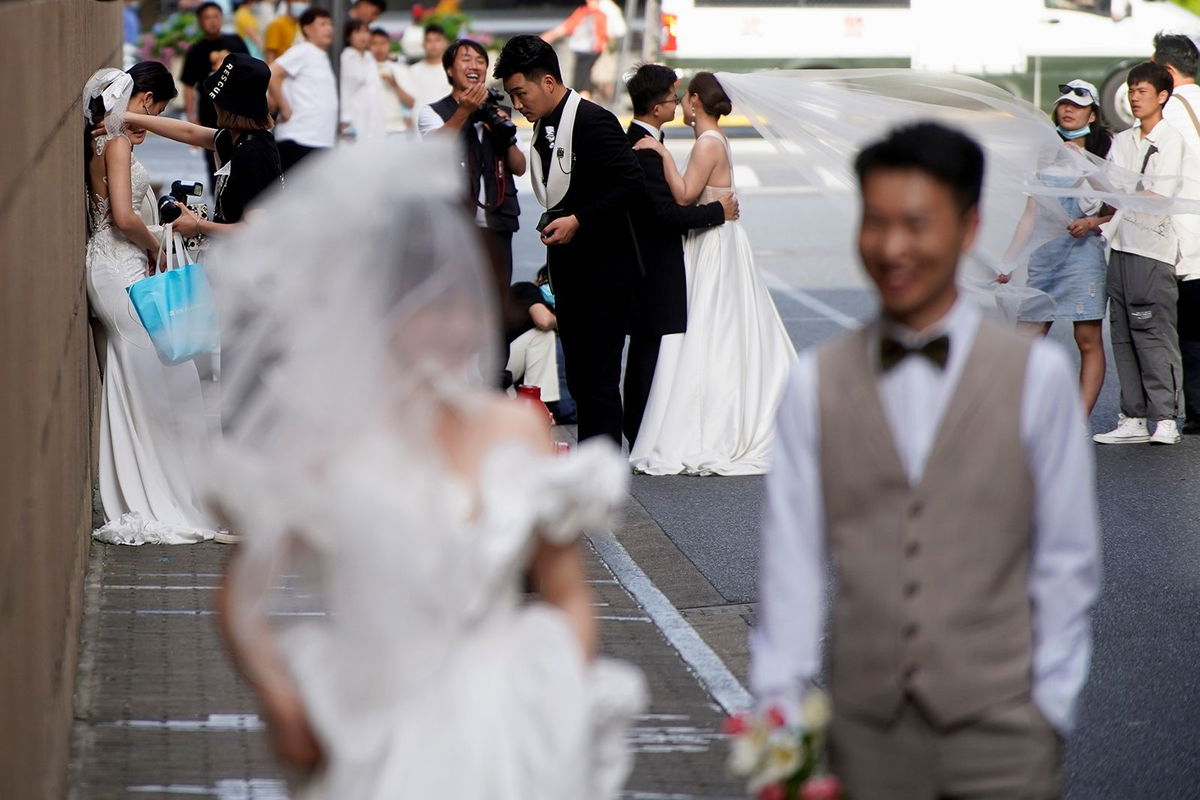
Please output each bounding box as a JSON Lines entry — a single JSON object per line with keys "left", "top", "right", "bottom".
{"left": 751, "top": 124, "right": 1100, "bottom": 800}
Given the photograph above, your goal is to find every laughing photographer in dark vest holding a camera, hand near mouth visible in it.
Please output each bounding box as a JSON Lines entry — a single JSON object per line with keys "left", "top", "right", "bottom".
{"left": 416, "top": 38, "right": 526, "bottom": 302}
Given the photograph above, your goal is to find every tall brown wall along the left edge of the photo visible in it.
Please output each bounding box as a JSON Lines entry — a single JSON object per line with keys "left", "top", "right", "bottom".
{"left": 0, "top": 0, "right": 121, "bottom": 800}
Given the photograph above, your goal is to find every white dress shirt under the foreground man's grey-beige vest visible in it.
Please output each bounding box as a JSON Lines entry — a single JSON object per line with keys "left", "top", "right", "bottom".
{"left": 750, "top": 299, "right": 1100, "bottom": 734}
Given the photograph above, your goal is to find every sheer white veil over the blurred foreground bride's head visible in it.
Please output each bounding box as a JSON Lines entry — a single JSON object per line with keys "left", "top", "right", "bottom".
{"left": 190, "top": 142, "right": 498, "bottom": 695}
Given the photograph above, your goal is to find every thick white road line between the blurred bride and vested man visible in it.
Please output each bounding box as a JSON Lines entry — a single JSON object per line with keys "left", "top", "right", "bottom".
{"left": 588, "top": 531, "right": 751, "bottom": 714}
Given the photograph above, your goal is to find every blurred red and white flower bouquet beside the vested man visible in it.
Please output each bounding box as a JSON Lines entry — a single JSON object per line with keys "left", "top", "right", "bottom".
{"left": 725, "top": 688, "right": 844, "bottom": 800}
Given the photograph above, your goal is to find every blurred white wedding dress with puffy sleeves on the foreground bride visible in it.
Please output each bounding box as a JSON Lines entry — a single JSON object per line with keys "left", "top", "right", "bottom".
{"left": 214, "top": 438, "right": 644, "bottom": 800}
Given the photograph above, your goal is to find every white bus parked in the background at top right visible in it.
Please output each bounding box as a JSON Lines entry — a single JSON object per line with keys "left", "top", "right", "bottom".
{"left": 661, "top": 0, "right": 1200, "bottom": 125}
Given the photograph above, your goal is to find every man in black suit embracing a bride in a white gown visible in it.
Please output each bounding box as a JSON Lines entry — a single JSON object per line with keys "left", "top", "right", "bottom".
{"left": 624, "top": 64, "right": 738, "bottom": 449}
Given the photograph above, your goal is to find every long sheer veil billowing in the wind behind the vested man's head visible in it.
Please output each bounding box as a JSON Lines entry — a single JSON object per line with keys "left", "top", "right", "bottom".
{"left": 718, "top": 70, "right": 1200, "bottom": 318}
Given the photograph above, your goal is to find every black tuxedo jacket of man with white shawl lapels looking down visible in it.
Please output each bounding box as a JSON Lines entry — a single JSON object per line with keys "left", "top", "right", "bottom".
{"left": 533, "top": 100, "right": 644, "bottom": 293}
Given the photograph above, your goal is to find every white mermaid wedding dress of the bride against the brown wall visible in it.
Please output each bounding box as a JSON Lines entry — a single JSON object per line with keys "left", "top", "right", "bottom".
{"left": 85, "top": 144, "right": 214, "bottom": 545}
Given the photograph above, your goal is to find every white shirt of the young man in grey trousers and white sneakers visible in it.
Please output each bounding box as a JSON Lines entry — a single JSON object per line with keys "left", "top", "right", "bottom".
{"left": 1103, "top": 122, "right": 1187, "bottom": 266}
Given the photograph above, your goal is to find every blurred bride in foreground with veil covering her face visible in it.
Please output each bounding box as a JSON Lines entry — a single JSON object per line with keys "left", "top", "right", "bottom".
{"left": 206, "top": 143, "right": 644, "bottom": 800}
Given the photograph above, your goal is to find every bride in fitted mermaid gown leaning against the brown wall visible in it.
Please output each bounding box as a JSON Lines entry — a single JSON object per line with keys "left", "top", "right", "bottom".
{"left": 84, "top": 67, "right": 214, "bottom": 545}
